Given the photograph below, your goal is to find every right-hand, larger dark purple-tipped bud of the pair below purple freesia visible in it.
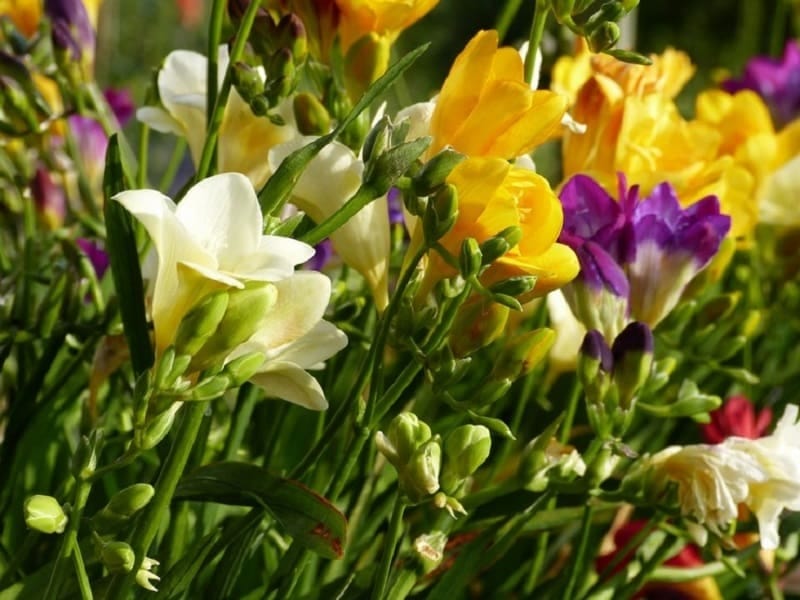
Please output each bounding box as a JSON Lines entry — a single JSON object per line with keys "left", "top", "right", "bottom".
{"left": 611, "top": 321, "right": 653, "bottom": 410}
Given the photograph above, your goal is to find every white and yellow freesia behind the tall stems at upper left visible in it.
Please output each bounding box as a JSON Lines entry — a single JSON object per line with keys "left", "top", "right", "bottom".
{"left": 136, "top": 45, "right": 298, "bottom": 188}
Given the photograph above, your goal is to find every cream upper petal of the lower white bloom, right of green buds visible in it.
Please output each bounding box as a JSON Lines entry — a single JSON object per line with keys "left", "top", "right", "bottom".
{"left": 251, "top": 271, "right": 331, "bottom": 351}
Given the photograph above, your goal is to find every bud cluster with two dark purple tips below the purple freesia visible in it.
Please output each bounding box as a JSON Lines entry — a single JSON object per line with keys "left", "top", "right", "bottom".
{"left": 578, "top": 321, "right": 653, "bottom": 438}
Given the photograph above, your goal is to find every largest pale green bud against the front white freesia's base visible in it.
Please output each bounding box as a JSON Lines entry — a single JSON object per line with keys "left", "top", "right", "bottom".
{"left": 192, "top": 281, "right": 278, "bottom": 371}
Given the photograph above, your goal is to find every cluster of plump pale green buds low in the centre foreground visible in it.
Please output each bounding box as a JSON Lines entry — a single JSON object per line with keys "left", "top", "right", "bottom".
{"left": 375, "top": 412, "right": 492, "bottom": 516}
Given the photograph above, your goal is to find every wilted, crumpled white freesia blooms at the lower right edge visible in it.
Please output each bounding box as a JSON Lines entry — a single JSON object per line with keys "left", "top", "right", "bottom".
{"left": 637, "top": 405, "right": 800, "bottom": 550}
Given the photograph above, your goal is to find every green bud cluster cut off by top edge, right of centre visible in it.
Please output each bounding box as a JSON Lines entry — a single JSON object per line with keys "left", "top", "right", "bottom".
{"left": 550, "top": 0, "right": 650, "bottom": 64}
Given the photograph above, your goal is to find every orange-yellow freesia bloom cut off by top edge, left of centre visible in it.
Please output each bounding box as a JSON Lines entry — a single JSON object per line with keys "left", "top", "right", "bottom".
{"left": 335, "top": 0, "right": 439, "bottom": 51}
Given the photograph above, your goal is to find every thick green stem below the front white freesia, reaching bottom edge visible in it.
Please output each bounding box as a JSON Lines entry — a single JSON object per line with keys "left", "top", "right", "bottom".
{"left": 106, "top": 402, "right": 208, "bottom": 600}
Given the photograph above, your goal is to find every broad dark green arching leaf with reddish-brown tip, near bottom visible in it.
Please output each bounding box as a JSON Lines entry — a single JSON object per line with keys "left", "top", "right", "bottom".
{"left": 174, "top": 462, "right": 347, "bottom": 558}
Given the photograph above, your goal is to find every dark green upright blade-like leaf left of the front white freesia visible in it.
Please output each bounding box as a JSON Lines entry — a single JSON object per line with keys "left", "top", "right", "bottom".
{"left": 103, "top": 134, "right": 154, "bottom": 375}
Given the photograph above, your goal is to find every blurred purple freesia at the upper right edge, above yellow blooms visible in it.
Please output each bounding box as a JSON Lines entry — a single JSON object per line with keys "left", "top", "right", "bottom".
{"left": 722, "top": 40, "right": 800, "bottom": 127}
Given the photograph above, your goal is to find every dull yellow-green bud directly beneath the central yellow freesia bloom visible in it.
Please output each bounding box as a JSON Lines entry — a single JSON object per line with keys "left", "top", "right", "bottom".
{"left": 449, "top": 295, "right": 508, "bottom": 358}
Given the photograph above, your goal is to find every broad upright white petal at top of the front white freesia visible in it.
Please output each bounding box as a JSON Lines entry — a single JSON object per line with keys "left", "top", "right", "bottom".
{"left": 176, "top": 173, "right": 263, "bottom": 273}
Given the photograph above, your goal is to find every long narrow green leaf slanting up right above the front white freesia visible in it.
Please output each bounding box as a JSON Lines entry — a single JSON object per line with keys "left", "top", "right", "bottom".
{"left": 258, "top": 44, "right": 430, "bottom": 214}
